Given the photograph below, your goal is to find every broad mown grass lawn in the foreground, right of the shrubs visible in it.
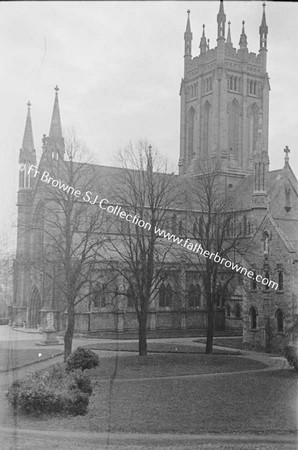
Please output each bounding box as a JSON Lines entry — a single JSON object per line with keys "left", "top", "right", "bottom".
{"left": 3, "top": 354, "right": 298, "bottom": 434}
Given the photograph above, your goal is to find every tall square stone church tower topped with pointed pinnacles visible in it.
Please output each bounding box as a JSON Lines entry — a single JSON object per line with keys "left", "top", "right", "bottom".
{"left": 179, "top": 1, "right": 270, "bottom": 185}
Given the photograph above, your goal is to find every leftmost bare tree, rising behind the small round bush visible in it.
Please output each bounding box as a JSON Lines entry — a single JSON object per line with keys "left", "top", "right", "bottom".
{"left": 32, "top": 135, "right": 106, "bottom": 359}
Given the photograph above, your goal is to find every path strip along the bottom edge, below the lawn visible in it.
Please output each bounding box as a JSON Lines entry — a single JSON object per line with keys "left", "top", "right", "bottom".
{"left": 0, "top": 428, "right": 298, "bottom": 450}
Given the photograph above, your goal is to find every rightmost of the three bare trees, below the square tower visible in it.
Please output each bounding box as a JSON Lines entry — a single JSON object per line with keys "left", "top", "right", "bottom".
{"left": 184, "top": 164, "right": 249, "bottom": 354}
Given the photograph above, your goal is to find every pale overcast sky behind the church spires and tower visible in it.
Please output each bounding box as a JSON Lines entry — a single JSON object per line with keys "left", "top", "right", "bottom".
{"left": 0, "top": 1, "right": 298, "bottom": 246}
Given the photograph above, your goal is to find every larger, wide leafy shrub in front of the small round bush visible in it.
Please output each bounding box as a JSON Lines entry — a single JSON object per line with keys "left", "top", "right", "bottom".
{"left": 7, "top": 366, "right": 92, "bottom": 415}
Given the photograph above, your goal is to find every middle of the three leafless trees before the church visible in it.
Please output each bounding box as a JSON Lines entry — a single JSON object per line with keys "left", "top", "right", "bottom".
{"left": 106, "top": 141, "right": 176, "bottom": 356}
